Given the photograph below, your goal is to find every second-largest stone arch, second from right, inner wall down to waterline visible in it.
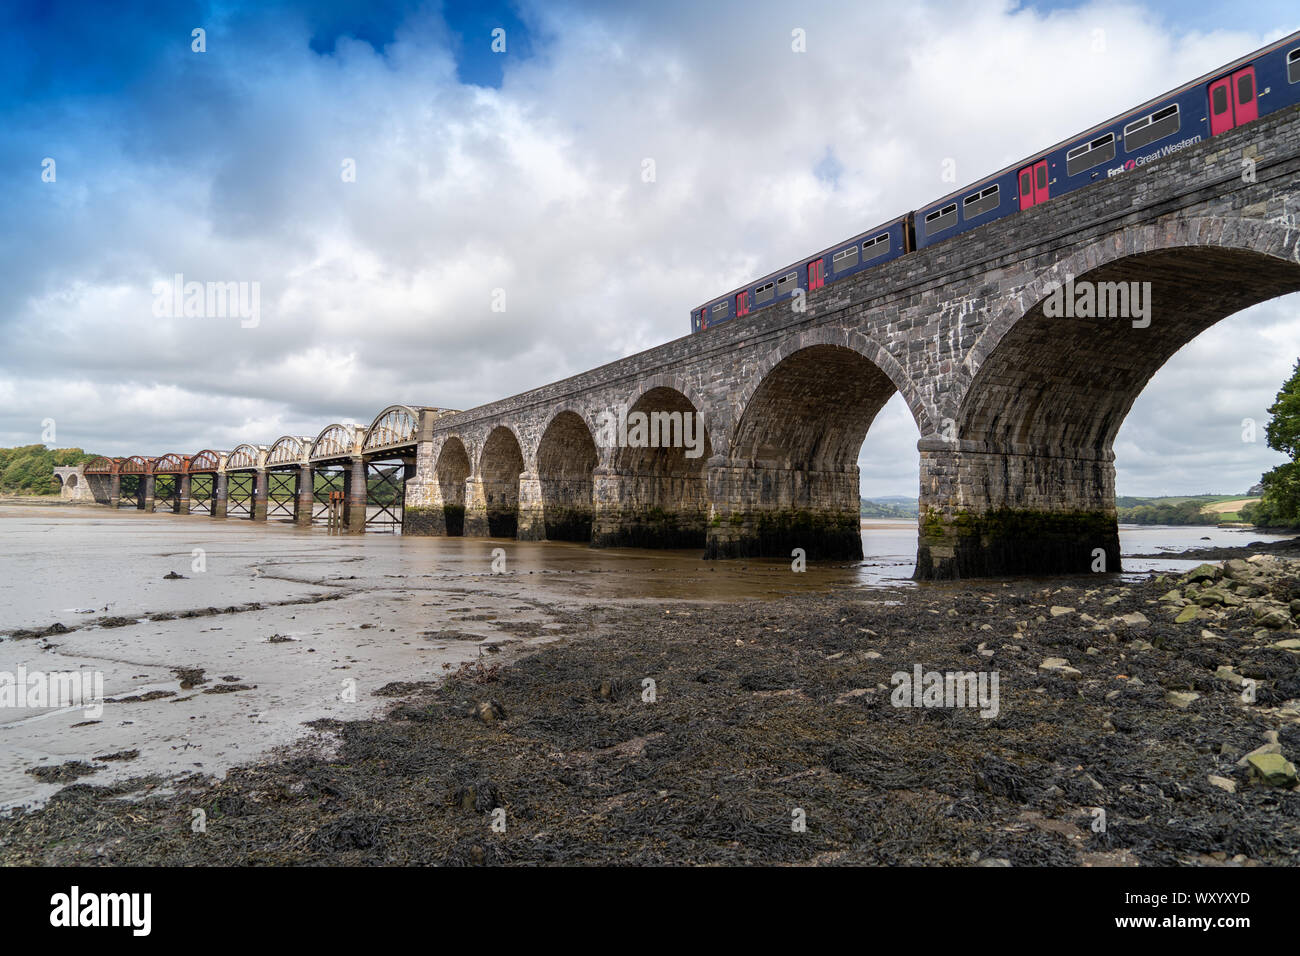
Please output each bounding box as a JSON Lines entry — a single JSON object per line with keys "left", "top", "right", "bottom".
{"left": 709, "top": 336, "right": 915, "bottom": 559}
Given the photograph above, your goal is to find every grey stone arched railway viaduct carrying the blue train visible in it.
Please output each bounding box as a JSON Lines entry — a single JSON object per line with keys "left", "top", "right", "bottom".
{"left": 68, "top": 107, "right": 1300, "bottom": 579}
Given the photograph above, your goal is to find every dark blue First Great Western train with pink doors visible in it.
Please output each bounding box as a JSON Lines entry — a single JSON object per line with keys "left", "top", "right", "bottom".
{"left": 690, "top": 31, "right": 1300, "bottom": 333}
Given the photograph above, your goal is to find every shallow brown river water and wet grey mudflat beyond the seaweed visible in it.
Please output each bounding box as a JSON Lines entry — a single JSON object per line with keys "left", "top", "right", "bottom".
{"left": 0, "top": 505, "right": 1275, "bottom": 806}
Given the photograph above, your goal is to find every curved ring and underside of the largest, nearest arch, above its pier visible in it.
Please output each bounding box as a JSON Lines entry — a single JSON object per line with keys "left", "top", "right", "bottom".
{"left": 953, "top": 219, "right": 1300, "bottom": 460}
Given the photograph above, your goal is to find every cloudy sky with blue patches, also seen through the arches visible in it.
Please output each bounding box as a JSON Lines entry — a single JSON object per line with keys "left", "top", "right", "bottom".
{"left": 0, "top": 0, "right": 1300, "bottom": 496}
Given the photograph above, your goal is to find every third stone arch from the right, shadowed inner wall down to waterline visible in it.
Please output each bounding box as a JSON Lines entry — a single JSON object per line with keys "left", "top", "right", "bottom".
{"left": 593, "top": 385, "right": 714, "bottom": 548}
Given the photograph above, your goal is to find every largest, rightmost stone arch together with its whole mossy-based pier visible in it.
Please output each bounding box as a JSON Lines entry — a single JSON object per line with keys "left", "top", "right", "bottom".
{"left": 917, "top": 217, "right": 1300, "bottom": 578}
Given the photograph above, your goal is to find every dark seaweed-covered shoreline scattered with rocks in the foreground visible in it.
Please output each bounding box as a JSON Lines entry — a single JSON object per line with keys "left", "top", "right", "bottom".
{"left": 0, "top": 538, "right": 1300, "bottom": 866}
